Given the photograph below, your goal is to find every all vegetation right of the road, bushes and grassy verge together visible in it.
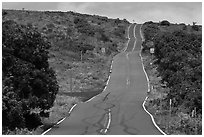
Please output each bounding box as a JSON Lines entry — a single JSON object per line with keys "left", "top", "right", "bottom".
{"left": 142, "top": 21, "right": 202, "bottom": 135}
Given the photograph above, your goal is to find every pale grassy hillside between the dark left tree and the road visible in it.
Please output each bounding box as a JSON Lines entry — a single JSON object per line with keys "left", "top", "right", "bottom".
{"left": 2, "top": 10, "right": 129, "bottom": 134}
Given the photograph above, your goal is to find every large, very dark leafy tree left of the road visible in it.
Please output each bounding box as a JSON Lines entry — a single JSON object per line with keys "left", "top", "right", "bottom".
{"left": 2, "top": 20, "right": 58, "bottom": 131}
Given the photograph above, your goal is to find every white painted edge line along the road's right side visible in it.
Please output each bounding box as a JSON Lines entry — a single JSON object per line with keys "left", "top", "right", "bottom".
{"left": 140, "top": 25, "right": 167, "bottom": 135}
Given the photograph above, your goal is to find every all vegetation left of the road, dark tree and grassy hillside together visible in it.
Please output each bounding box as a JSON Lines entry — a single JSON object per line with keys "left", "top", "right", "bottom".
{"left": 2, "top": 10, "right": 129, "bottom": 134}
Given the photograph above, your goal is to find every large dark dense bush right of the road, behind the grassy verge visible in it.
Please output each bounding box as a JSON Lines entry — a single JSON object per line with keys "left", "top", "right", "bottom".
{"left": 154, "top": 31, "right": 202, "bottom": 113}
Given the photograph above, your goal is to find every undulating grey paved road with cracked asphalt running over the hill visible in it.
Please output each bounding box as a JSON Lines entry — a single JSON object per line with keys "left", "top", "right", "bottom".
{"left": 47, "top": 24, "right": 161, "bottom": 135}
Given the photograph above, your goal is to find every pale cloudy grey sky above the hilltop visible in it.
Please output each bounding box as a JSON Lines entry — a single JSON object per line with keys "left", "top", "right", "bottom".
{"left": 2, "top": 2, "right": 202, "bottom": 24}
